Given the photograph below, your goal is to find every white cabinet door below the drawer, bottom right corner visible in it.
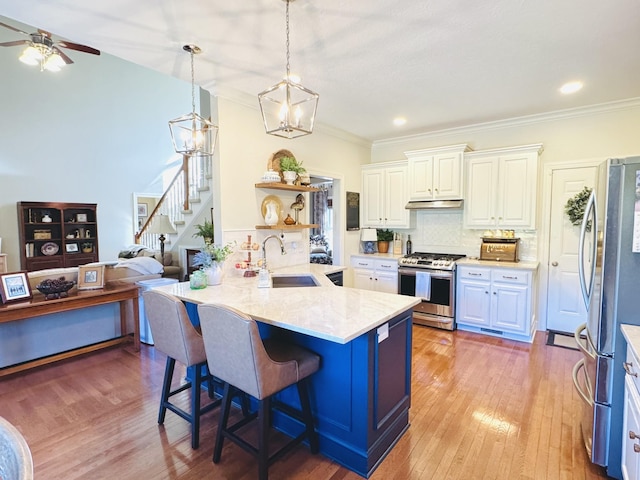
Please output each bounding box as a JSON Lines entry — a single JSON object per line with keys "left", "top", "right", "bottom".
{"left": 622, "top": 375, "right": 640, "bottom": 480}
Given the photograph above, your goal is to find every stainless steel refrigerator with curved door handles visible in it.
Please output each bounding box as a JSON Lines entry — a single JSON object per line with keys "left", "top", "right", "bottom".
{"left": 573, "top": 157, "right": 640, "bottom": 478}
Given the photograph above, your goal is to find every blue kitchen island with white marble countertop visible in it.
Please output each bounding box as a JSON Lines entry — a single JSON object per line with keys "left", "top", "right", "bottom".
{"left": 156, "top": 265, "right": 419, "bottom": 477}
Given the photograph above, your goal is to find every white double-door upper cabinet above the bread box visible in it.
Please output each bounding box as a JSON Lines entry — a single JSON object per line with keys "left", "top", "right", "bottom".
{"left": 464, "top": 144, "right": 542, "bottom": 229}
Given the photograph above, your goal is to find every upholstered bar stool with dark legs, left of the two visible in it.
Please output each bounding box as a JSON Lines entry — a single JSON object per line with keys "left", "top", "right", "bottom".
{"left": 142, "top": 290, "right": 221, "bottom": 449}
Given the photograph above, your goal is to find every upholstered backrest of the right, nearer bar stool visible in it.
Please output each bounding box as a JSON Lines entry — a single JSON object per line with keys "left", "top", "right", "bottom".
{"left": 198, "top": 304, "right": 297, "bottom": 400}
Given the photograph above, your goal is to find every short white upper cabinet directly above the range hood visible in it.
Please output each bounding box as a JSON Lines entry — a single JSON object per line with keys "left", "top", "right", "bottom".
{"left": 404, "top": 145, "right": 469, "bottom": 200}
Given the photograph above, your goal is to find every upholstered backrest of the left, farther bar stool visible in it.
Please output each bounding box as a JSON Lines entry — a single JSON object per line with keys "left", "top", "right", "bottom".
{"left": 142, "top": 290, "right": 206, "bottom": 365}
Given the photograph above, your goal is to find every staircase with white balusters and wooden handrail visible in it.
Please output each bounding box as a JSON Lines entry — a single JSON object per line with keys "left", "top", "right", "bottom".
{"left": 134, "top": 155, "right": 212, "bottom": 251}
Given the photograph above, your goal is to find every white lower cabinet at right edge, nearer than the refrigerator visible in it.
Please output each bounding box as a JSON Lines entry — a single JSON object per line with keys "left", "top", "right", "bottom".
{"left": 622, "top": 347, "right": 640, "bottom": 480}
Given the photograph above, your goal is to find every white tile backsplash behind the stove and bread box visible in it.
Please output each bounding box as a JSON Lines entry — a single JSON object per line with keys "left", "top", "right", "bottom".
{"left": 397, "top": 210, "right": 537, "bottom": 261}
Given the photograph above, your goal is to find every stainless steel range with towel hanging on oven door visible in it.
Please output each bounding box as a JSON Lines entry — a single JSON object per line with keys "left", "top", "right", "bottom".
{"left": 398, "top": 252, "right": 464, "bottom": 330}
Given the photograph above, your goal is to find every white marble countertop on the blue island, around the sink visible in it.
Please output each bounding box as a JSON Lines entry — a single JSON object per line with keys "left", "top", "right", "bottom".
{"left": 154, "top": 264, "right": 420, "bottom": 344}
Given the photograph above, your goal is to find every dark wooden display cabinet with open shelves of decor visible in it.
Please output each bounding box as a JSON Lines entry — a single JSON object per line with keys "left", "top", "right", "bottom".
{"left": 18, "top": 202, "right": 98, "bottom": 271}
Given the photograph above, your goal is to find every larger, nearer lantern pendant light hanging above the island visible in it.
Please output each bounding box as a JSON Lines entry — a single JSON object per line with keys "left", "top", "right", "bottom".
{"left": 258, "top": 0, "right": 320, "bottom": 138}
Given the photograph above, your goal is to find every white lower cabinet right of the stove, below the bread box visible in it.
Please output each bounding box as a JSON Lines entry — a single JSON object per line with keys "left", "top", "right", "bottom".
{"left": 456, "top": 265, "right": 535, "bottom": 342}
